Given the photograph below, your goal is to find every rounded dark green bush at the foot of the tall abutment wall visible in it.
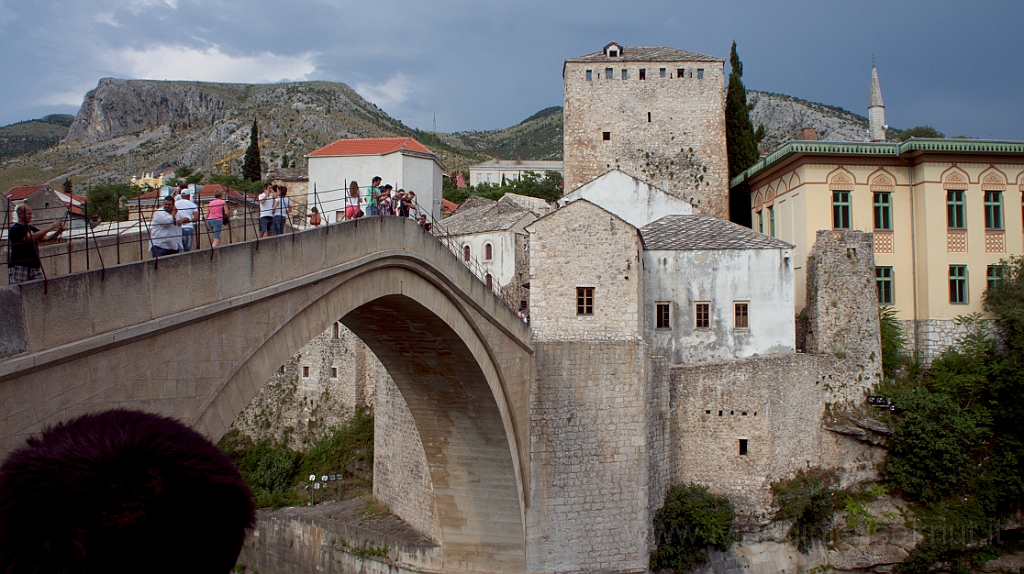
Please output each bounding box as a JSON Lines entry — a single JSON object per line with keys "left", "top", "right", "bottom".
{"left": 650, "top": 484, "right": 739, "bottom": 573}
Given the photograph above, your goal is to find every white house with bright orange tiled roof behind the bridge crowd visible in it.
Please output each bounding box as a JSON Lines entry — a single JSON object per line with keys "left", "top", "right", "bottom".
{"left": 306, "top": 137, "right": 444, "bottom": 222}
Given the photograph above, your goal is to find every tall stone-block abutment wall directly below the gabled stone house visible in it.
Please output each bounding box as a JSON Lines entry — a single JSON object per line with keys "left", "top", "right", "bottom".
{"left": 526, "top": 341, "right": 668, "bottom": 572}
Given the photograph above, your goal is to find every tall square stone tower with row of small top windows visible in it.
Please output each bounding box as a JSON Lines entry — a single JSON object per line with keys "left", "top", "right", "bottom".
{"left": 562, "top": 43, "right": 729, "bottom": 219}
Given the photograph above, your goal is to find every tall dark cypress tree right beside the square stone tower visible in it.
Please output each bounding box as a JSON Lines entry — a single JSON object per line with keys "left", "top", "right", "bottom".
{"left": 725, "top": 41, "right": 758, "bottom": 227}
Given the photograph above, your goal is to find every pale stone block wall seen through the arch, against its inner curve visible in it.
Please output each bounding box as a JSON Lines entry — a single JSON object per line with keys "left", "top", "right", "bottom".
{"left": 374, "top": 377, "right": 437, "bottom": 538}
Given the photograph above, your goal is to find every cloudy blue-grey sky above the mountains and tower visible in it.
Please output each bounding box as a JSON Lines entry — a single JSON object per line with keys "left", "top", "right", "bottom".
{"left": 0, "top": 0, "right": 1024, "bottom": 139}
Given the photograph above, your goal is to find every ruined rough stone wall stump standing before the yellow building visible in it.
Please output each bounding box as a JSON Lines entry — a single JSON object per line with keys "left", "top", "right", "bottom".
{"left": 803, "top": 230, "right": 882, "bottom": 403}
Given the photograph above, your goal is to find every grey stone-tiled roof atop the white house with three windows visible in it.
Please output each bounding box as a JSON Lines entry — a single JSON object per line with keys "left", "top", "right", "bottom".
{"left": 640, "top": 215, "right": 794, "bottom": 251}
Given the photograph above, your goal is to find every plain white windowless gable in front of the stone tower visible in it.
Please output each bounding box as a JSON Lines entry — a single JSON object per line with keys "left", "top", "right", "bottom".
{"left": 558, "top": 170, "right": 693, "bottom": 228}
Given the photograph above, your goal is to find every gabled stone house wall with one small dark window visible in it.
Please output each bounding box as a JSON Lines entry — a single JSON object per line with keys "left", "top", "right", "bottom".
{"left": 528, "top": 200, "right": 643, "bottom": 341}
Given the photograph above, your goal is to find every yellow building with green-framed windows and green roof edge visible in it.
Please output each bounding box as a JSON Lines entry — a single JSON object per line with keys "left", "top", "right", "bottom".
{"left": 731, "top": 138, "right": 1024, "bottom": 361}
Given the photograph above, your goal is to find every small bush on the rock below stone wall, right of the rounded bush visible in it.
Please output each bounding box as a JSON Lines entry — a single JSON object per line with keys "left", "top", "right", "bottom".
{"left": 771, "top": 470, "right": 847, "bottom": 553}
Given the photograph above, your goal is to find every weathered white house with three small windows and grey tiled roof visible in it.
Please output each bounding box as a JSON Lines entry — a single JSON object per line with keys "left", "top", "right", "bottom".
{"left": 640, "top": 215, "right": 796, "bottom": 364}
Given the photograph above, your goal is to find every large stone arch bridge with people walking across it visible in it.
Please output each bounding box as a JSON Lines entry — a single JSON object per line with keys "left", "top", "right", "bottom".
{"left": 0, "top": 218, "right": 534, "bottom": 571}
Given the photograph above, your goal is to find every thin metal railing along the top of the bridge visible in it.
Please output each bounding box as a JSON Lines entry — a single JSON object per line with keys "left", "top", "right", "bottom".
{"left": 0, "top": 182, "right": 517, "bottom": 310}
